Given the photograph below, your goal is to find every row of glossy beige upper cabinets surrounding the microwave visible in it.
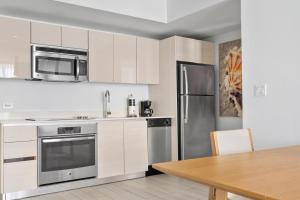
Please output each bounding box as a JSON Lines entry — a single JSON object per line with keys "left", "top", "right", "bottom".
{"left": 0, "top": 17, "right": 162, "bottom": 84}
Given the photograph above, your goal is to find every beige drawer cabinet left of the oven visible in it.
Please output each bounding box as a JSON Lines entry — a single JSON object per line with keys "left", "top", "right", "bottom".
{"left": 1, "top": 125, "right": 38, "bottom": 193}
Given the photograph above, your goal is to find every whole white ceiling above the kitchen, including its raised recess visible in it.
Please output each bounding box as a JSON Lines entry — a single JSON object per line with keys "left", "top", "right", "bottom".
{"left": 0, "top": 0, "right": 241, "bottom": 39}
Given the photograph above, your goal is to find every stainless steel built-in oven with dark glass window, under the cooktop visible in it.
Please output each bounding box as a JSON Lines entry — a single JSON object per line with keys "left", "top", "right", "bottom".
{"left": 38, "top": 123, "right": 97, "bottom": 185}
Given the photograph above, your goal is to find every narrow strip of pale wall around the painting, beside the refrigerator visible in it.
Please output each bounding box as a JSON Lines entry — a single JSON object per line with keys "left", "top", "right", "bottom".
{"left": 206, "top": 29, "right": 243, "bottom": 130}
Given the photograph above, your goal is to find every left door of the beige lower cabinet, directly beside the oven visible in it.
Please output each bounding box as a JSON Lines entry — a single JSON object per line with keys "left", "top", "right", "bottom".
{"left": 98, "top": 121, "right": 124, "bottom": 178}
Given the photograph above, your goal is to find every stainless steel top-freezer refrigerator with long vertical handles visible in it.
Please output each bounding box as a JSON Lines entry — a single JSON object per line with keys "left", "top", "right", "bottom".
{"left": 177, "top": 62, "right": 215, "bottom": 160}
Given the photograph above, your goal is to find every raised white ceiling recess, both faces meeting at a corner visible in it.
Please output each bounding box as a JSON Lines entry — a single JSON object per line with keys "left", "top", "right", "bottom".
{"left": 54, "top": 0, "right": 225, "bottom": 23}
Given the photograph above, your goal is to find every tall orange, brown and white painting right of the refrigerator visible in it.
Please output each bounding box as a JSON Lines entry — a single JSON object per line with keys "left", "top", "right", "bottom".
{"left": 219, "top": 40, "right": 243, "bottom": 117}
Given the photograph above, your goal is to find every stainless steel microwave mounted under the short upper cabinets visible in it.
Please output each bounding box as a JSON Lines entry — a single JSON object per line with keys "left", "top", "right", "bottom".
{"left": 31, "top": 45, "right": 88, "bottom": 82}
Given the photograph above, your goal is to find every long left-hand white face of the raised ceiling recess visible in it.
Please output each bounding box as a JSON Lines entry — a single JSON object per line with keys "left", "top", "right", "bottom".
{"left": 55, "top": 0, "right": 167, "bottom": 23}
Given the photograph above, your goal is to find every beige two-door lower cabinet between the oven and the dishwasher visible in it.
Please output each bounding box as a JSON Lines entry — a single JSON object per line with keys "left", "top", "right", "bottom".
{"left": 98, "top": 120, "right": 148, "bottom": 178}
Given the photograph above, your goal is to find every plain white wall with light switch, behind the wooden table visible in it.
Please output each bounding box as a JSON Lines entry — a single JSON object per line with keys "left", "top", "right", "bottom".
{"left": 241, "top": 0, "right": 300, "bottom": 149}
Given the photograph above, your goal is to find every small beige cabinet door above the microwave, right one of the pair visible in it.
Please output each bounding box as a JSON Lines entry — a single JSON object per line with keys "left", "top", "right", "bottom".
{"left": 61, "top": 26, "right": 88, "bottom": 49}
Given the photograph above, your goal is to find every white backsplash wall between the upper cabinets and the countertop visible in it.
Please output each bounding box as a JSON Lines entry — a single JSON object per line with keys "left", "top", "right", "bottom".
{"left": 0, "top": 79, "right": 148, "bottom": 116}
